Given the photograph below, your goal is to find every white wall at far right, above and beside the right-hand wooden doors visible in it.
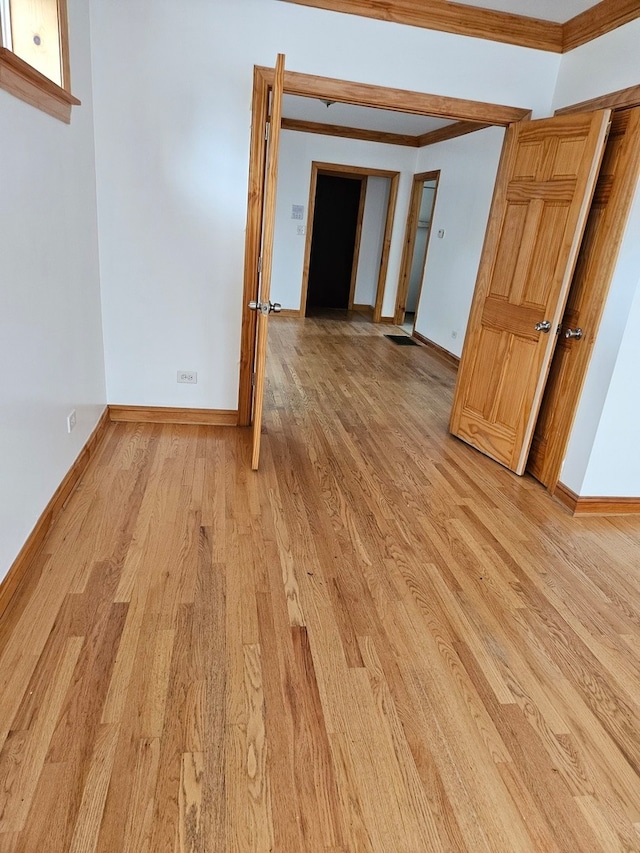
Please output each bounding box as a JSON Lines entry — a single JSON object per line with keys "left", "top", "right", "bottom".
{"left": 554, "top": 20, "right": 640, "bottom": 497}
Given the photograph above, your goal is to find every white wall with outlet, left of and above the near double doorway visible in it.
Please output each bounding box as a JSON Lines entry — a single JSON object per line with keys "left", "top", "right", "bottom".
{"left": 91, "top": 0, "right": 560, "bottom": 408}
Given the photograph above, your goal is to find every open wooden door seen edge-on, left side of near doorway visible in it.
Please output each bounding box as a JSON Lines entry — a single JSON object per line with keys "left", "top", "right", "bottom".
{"left": 249, "top": 53, "right": 284, "bottom": 471}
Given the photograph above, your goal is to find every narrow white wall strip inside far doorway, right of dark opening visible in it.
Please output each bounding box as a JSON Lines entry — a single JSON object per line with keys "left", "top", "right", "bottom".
{"left": 353, "top": 177, "right": 388, "bottom": 307}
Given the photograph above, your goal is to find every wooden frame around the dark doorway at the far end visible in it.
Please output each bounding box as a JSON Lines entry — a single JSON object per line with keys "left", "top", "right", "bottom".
{"left": 300, "top": 160, "right": 400, "bottom": 323}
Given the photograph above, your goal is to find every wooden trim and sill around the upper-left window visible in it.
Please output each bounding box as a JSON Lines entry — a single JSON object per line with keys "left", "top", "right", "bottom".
{"left": 0, "top": 0, "right": 80, "bottom": 124}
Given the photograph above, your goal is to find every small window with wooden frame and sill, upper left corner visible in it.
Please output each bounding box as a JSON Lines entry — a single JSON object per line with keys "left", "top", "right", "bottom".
{"left": 0, "top": 0, "right": 80, "bottom": 122}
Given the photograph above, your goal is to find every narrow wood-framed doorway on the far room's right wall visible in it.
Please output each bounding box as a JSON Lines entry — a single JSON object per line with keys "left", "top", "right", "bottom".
{"left": 393, "top": 171, "right": 440, "bottom": 335}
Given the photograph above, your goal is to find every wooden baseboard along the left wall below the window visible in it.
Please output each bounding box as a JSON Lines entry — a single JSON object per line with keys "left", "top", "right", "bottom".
{"left": 0, "top": 408, "right": 111, "bottom": 617}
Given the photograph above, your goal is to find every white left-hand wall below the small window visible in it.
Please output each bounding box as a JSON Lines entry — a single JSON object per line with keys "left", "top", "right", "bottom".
{"left": 0, "top": 0, "right": 106, "bottom": 579}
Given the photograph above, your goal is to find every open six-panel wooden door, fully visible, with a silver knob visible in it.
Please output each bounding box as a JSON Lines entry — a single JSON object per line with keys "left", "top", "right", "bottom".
{"left": 450, "top": 110, "right": 610, "bottom": 474}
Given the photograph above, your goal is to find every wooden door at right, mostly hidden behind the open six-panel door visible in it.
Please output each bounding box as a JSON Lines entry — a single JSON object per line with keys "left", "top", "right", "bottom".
{"left": 527, "top": 108, "right": 640, "bottom": 491}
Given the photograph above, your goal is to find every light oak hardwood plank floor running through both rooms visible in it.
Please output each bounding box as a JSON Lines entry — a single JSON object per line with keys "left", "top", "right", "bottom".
{"left": 0, "top": 318, "right": 640, "bottom": 853}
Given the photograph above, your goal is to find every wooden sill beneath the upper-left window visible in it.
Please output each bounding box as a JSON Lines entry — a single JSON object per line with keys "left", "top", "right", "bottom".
{"left": 0, "top": 47, "right": 80, "bottom": 124}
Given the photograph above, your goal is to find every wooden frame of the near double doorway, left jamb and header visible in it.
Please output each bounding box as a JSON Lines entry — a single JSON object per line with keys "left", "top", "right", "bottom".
{"left": 238, "top": 66, "right": 531, "bottom": 426}
